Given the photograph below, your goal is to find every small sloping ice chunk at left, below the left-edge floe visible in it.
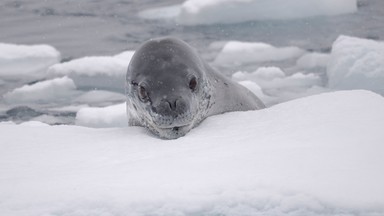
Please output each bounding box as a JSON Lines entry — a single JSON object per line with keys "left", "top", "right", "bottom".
{"left": 3, "top": 76, "right": 78, "bottom": 104}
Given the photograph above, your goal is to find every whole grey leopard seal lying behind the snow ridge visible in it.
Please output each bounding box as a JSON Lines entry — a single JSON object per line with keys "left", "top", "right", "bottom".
{"left": 125, "top": 37, "right": 265, "bottom": 139}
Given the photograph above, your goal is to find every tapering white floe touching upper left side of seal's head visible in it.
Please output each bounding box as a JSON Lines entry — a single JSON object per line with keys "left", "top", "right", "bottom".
{"left": 48, "top": 51, "right": 134, "bottom": 92}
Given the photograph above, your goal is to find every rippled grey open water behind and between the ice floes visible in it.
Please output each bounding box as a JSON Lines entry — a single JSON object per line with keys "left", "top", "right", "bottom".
{"left": 0, "top": 0, "right": 384, "bottom": 123}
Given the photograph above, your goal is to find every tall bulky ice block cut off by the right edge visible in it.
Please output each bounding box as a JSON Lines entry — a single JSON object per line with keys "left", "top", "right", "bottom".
{"left": 327, "top": 36, "right": 384, "bottom": 94}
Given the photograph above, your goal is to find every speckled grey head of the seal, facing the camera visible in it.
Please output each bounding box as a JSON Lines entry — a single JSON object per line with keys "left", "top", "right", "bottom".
{"left": 126, "top": 39, "right": 210, "bottom": 139}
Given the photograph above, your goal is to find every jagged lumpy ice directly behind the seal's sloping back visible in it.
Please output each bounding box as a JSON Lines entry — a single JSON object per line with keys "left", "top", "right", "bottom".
{"left": 232, "top": 67, "right": 326, "bottom": 106}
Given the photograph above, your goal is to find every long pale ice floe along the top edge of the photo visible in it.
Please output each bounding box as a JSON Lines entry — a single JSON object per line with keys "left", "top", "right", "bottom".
{"left": 139, "top": 0, "right": 357, "bottom": 25}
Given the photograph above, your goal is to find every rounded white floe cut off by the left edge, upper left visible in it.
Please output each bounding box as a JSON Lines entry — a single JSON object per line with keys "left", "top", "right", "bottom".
{"left": 0, "top": 43, "right": 61, "bottom": 81}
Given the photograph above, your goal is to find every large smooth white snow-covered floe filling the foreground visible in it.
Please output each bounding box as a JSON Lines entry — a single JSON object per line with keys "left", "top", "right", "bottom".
{"left": 0, "top": 90, "right": 384, "bottom": 216}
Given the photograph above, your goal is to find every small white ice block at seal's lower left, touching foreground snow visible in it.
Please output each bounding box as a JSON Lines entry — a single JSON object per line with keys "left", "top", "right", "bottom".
{"left": 76, "top": 103, "right": 128, "bottom": 128}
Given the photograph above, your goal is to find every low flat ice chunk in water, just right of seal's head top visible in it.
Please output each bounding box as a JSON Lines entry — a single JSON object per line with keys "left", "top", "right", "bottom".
{"left": 213, "top": 41, "right": 305, "bottom": 66}
